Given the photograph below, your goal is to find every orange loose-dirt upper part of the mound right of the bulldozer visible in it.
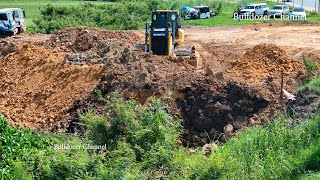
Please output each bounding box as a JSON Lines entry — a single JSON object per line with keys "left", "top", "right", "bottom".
{"left": 228, "top": 44, "right": 303, "bottom": 84}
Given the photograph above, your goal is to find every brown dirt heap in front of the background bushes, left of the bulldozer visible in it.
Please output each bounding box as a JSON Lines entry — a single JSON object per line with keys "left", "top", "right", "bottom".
{"left": 48, "top": 27, "right": 142, "bottom": 52}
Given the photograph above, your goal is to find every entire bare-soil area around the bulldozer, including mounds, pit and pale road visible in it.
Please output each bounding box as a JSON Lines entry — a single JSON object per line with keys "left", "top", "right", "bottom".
{"left": 0, "top": 24, "right": 320, "bottom": 146}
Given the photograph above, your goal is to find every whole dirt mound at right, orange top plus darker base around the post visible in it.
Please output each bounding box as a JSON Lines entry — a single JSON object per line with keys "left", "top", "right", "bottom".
{"left": 226, "top": 44, "right": 305, "bottom": 102}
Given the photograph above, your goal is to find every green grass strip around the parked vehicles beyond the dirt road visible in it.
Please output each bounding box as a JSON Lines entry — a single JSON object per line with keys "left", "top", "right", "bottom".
{"left": 183, "top": 0, "right": 320, "bottom": 26}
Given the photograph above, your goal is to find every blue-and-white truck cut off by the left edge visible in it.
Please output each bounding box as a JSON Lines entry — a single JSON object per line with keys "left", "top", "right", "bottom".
{"left": 0, "top": 9, "right": 18, "bottom": 35}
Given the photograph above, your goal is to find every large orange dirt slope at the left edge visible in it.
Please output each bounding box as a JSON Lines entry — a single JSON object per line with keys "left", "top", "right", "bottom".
{"left": 0, "top": 45, "right": 102, "bottom": 130}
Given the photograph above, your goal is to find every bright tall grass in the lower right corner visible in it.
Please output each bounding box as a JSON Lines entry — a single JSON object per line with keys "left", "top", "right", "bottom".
{"left": 212, "top": 115, "right": 320, "bottom": 179}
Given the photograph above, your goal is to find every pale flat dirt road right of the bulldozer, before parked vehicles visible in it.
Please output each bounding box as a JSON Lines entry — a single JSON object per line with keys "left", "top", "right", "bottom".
{"left": 185, "top": 23, "right": 320, "bottom": 52}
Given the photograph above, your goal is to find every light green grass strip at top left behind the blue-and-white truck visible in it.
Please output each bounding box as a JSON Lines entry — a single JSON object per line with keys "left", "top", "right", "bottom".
{"left": 0, "top": 0, "right": 111, "bottom": 27}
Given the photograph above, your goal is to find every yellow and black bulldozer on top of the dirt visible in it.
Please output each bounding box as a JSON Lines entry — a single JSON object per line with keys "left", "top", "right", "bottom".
{"left": 140, "top": 10, "right": 199, "bottom": 68}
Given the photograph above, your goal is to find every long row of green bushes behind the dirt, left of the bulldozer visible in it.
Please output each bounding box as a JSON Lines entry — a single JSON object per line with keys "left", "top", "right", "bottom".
{"left": 30, "top": 2, "right": 150, "bottom": 34}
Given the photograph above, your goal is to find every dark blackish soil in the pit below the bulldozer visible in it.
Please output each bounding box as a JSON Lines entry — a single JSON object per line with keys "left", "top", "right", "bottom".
{"left": 176, "top": 82, "right": 268, "bottom": 146}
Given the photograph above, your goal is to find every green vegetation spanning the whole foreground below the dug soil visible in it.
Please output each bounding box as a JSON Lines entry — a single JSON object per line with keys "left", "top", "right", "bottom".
{"left": 0, "top": 78, "right": 320, "bottom": 179}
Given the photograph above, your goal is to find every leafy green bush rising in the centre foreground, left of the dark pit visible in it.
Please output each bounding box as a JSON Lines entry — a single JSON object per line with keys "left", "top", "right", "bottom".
{"left": 81, "top": 94, "right": 180, "bottom": 168}
